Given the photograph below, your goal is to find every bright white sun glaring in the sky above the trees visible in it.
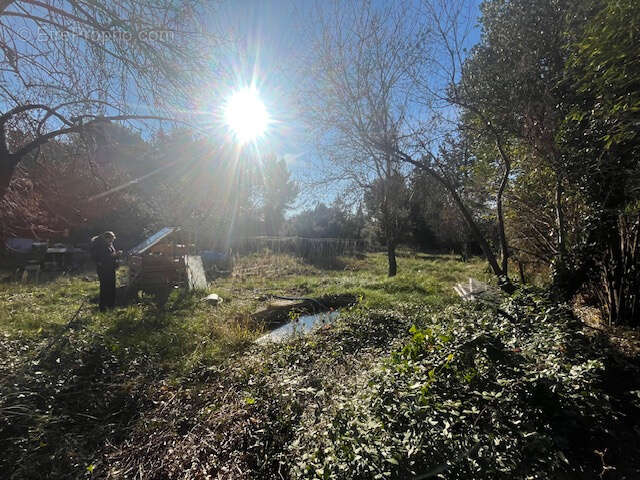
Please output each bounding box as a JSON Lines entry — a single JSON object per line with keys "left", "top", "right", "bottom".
{"left": 224, "top": 87, "right": 270, "bottom": 143}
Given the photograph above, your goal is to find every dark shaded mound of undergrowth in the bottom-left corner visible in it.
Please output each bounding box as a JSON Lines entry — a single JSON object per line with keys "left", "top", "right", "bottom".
{"left": 0, "top": 336, "right": 145, "bottom": 479}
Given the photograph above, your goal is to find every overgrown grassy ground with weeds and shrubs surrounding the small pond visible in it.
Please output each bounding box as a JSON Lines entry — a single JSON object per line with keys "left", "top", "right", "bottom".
{"left": 0, "top": 254, "right": 640, "bottom": 479}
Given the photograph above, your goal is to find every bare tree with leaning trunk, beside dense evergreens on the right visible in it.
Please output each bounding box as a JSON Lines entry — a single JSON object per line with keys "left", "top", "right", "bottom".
{"left": 307, "top": 0, "right": 513, "bottom": 291}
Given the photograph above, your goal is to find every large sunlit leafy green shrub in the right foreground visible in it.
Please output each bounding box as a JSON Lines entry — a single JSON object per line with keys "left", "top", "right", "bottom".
{"left": 291, "top": 293, "right": 610, "bottom": 479}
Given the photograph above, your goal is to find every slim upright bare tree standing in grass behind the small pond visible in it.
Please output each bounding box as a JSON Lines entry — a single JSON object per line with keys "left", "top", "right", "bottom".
{"left": 305, "top": 2, "right": 420, "bottom": 276}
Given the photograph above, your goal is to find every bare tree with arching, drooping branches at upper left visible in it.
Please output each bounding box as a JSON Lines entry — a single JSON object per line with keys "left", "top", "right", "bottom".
{"left": 0, "top": 0, "right": 218, "bottom": 198}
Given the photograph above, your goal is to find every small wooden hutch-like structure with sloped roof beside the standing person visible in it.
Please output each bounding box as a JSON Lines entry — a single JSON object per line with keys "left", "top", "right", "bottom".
{"left": 127, "top": 227, "right": 207, "bottom": 291}
